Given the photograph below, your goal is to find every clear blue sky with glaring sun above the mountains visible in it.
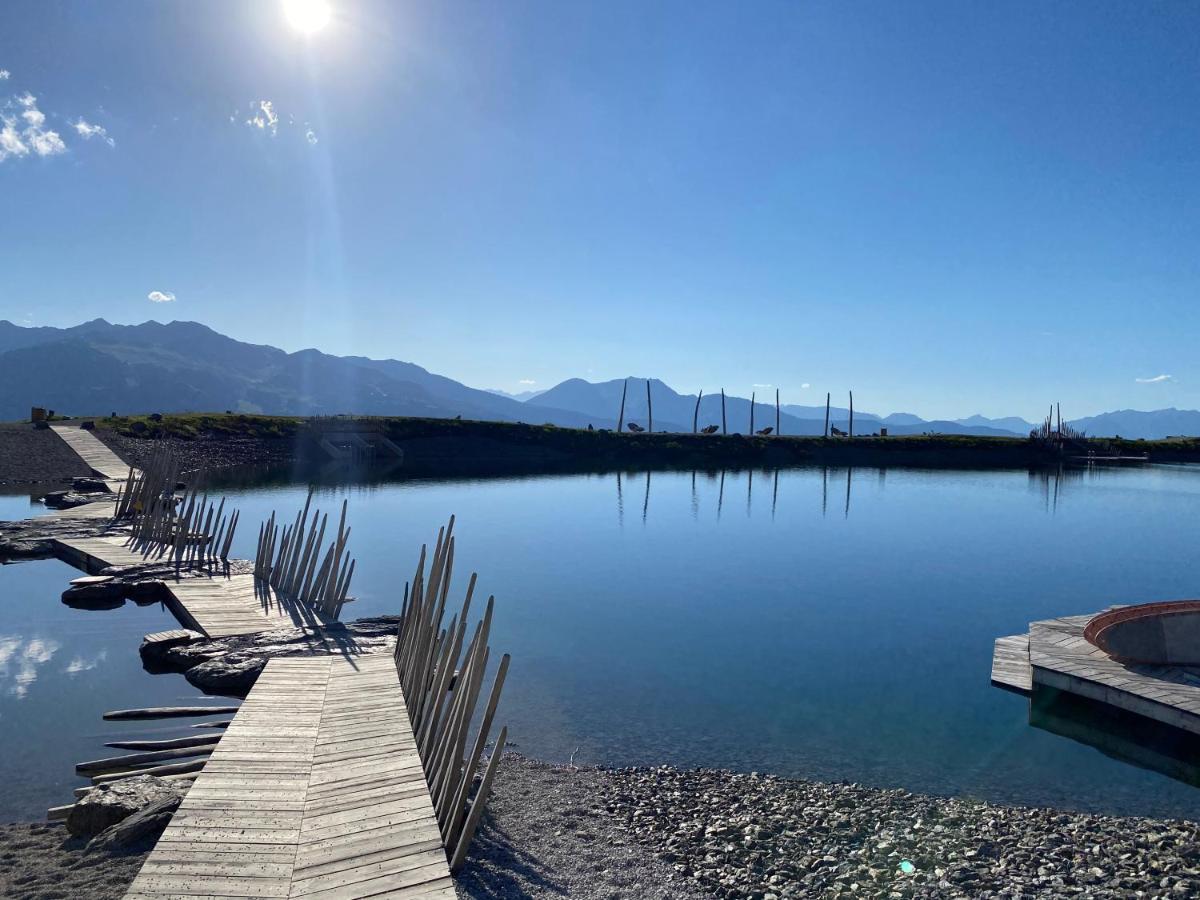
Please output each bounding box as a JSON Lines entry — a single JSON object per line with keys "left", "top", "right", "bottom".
{"left": 0, "top": 0, "right": 1200, "bottom": 418}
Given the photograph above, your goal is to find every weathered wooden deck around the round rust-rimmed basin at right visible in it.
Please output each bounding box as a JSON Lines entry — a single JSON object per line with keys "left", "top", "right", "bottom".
{"left": 992, "top": 616, "right": 1200, "bottom": 734}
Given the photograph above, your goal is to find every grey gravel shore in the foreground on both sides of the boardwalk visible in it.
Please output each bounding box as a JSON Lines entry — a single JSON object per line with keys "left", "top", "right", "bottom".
{"left": 0, "top": 754, "right": 1200, "bottom": 900}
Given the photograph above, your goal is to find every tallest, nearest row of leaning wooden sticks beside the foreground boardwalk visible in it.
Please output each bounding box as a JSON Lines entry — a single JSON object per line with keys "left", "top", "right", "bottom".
{"left": 396, "top": 517, "right": 509, "bottom": 872}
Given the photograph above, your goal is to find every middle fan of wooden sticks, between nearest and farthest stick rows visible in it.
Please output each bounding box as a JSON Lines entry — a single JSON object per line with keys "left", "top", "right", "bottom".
{"left": 254, "top": 490, "right": 355, "bottom": 619}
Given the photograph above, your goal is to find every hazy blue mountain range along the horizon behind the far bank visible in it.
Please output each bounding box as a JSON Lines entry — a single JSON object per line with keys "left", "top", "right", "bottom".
{"left": 0, "top": 319, "right": 1200, "bottom": 438}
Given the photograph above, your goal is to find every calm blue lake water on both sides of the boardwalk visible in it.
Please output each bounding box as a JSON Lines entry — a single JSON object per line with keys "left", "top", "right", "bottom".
{"left": 0, "top": 467, "right": 1200, "bottom": 820}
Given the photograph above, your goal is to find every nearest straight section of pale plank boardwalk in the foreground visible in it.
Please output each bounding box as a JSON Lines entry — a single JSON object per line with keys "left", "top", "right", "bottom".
{"left": 126, "top": 653, "right": 456, "bottom": 900}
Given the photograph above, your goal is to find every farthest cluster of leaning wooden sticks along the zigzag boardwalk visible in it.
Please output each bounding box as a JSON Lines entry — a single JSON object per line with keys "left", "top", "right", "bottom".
{"left": 116, "top": 448, "right": 239, "bottom": 569}
